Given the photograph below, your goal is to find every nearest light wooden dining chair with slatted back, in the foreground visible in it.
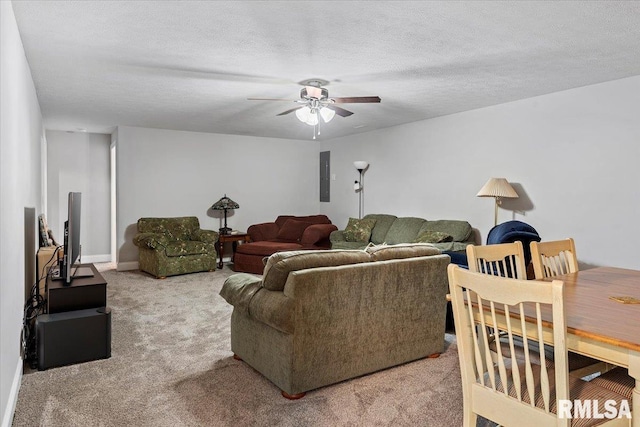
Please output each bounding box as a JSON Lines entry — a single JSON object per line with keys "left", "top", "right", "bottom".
{"left": 448, "top": 264, "right": 629, "bottom": 427}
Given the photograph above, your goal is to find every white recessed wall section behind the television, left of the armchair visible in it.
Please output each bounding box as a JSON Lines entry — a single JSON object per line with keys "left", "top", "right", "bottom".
{"left": 46, "top": 130, "right": 111, "bottom": 262}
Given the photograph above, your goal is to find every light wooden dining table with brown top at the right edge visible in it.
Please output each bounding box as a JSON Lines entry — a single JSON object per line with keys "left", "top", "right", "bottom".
{"left": 524, "top": 267, "right": 640, "bottom": 427}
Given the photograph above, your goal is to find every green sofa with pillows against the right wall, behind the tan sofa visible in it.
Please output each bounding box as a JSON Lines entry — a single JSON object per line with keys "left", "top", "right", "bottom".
{"left": 330, "top": 214, "right": 476, "bottom": 252}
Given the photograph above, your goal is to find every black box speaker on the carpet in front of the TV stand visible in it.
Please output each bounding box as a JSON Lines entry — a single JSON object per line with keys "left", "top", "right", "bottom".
{"left": 36, "top": 307, "right": 111, "bottom": 370}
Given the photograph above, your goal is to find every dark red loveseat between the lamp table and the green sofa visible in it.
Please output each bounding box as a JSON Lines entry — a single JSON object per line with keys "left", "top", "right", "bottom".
{"left": 233, "top": 215, "right": 338, "bottom": 274}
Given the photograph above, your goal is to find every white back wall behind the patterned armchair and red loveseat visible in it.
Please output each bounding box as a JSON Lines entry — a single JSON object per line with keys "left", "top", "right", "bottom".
{"left": 116, "top": 127, "right": 320, "bottom": 269}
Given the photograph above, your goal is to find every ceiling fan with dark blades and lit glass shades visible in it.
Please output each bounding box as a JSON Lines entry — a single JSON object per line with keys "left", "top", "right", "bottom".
{"left": 247, "top": 79, "right": 380, "bottom": 139}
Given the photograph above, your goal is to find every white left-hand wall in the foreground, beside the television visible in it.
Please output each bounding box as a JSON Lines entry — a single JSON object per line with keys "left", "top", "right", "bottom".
{"left": 0, "top": 1, "right": 44, "bottom": 426}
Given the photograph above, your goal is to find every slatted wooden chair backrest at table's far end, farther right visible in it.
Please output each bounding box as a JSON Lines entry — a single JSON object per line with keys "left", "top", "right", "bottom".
{"left": 530, "top": 239, "right": 578, "bottom": 279}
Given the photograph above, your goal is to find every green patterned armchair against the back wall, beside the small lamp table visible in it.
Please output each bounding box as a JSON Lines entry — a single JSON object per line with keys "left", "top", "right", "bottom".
{"left": 133, "top": 216, "right": 218, "bottom": 278}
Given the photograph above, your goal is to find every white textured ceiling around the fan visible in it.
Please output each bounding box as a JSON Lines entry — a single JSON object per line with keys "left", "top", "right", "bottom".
{"left": 12, "top": 0, "right": 640, "bottom": 139}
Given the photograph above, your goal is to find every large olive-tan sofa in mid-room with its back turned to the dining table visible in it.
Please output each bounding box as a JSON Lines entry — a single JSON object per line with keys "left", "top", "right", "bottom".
{"left": 220, "top": 245, "right": 449, "bottom": 398}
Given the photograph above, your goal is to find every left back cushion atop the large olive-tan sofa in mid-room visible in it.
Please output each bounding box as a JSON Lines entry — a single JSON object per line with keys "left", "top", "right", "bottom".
{"left": 262, "top": 250, "right": 371, "bottom": 291}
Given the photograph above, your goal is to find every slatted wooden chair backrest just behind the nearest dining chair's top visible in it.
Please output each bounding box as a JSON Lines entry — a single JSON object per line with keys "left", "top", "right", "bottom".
{"left": 467, "top": 240, "right": 527, "bottom": 280}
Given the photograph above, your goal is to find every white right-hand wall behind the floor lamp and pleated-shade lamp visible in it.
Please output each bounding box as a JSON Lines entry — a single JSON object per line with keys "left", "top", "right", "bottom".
{"left": 320, "top": 76, "right": 640, "bottom": 269}
